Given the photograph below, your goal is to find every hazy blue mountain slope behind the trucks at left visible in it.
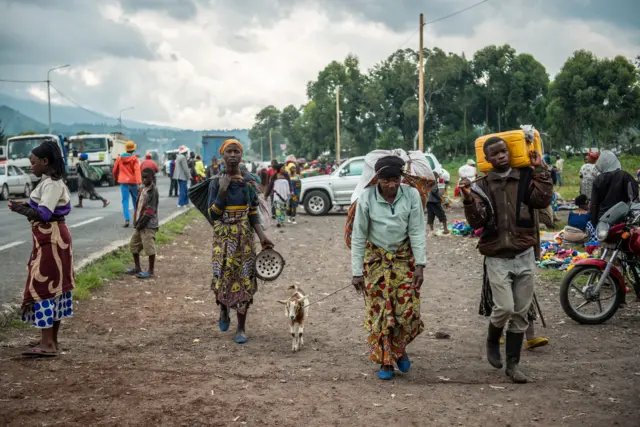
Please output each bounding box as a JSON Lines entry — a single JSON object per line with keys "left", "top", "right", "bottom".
{"left": 0, "top": 94, "right": 251, "bottom": 155}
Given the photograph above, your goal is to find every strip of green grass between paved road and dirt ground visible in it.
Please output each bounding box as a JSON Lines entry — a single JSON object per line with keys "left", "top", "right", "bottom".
{"left": 73, "top": 209, "right": 200, "bottom": 300}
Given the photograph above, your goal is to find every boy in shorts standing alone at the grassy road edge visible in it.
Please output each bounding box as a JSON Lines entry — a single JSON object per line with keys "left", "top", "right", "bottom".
{"left": 126, "top": 168, "right": 159, "bottom": 279}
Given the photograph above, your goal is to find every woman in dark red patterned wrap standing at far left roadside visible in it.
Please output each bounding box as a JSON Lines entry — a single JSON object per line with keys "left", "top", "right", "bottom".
{"left": 9, "top": 140, "right": 74, "bottom": 357}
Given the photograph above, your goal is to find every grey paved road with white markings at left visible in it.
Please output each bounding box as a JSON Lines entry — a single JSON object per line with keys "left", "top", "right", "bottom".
{"left": 0, "top": 176, "right": 185, "bottom": 304}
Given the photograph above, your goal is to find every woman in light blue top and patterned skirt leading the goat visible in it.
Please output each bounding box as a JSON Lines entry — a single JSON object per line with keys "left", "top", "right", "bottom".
{"left": 351, "top": 156, "right": 427, "bottom": 380}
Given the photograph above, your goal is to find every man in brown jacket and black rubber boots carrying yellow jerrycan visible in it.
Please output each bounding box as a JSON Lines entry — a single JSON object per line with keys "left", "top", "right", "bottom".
{"left": 460, "top": 136, "right": 553, "bottom": 383}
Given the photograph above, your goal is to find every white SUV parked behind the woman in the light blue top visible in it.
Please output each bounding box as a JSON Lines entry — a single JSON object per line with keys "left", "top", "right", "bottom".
{"left": 300, "top": 156, "right": 364, "bottom": 216}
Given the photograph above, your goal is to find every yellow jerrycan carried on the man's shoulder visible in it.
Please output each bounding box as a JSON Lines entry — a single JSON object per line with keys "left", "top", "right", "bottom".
{"left": 475, "top": 128, "right": 542, "bottom": 173}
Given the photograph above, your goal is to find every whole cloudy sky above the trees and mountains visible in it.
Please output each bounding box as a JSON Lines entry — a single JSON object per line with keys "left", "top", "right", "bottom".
{"left": 0, "top": 0, "right": 640, "bottom": 129}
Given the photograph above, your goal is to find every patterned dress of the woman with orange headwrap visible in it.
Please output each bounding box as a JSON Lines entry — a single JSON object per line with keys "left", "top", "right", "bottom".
{"left": 209, "top": 173, "right": 259, "bottom": 314}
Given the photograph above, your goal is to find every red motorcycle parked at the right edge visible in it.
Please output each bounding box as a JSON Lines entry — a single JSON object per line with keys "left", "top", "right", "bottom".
{"left": 560, "top": 202, "right": 640, "bottom": 325}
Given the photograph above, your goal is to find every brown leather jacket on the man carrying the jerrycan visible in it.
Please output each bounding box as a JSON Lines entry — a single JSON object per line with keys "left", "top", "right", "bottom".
{"left": 464, "top": 167, "right": 553, "bottom": 258}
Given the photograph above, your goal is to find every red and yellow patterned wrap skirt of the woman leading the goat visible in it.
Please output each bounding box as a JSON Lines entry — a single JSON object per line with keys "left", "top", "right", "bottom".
{"left": 364, "top": 241, "right": 424, "bottom": 365}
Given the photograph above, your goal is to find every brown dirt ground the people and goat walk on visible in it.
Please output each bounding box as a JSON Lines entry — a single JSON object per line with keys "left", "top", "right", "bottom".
{"left": 0, "top": 212, "right": 640, "bottom": 427}
